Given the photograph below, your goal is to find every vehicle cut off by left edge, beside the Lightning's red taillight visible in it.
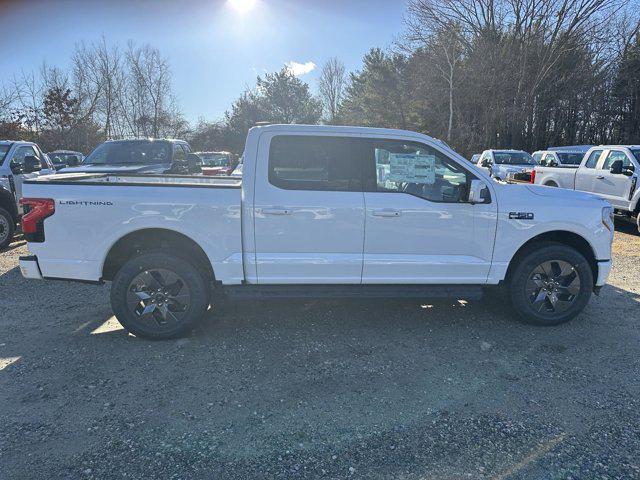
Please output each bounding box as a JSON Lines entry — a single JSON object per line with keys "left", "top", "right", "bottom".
{"left": 0, "top": 140, "right": 56, "bottom": 249}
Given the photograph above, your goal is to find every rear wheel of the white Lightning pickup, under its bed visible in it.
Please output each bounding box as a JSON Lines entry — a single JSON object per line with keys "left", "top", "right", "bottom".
{"left": 111, "top": 252, "right": 209, "bottom": 340}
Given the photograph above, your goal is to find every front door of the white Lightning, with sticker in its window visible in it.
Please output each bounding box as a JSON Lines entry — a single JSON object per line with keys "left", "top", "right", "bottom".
{"left": 362, "top": 139, "right": 497, "bottom": 284}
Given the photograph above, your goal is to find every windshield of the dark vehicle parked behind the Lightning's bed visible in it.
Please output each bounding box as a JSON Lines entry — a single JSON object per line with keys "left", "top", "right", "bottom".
{"left": 84, "top": 140, "right": 171, "bottom": 165}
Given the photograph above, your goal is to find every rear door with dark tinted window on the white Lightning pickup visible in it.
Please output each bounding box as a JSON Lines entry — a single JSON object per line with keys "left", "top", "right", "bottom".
{"left": 254, "top": 132, "right": 364, "bottom": 284}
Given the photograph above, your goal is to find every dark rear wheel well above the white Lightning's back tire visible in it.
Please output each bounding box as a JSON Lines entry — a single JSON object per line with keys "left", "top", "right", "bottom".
{"left": 102, "top": 228, "right": 215, "bottom": 281}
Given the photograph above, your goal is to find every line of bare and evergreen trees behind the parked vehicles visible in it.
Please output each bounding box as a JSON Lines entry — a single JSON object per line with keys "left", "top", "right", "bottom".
{"left": 0, "top": 0, "right": 640, "bottom": 155}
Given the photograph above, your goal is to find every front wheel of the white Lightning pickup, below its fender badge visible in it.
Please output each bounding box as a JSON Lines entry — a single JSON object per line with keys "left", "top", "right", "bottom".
{"left": 509, "top": 242, "right": 593, "bottom": 326}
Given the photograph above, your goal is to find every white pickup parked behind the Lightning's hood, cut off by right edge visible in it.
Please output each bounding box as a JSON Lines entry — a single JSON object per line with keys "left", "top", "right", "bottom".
{"left": 531, "top": 145, "right": 640, "bottom": 231}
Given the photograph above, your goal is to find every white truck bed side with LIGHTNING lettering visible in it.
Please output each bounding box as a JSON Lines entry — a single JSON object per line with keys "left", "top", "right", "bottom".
{"left": 24, "top": 173, "right": 244, "bottom": 284}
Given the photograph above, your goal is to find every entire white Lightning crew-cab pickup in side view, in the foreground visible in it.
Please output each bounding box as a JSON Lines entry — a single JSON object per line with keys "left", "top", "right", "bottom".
{"left": 20, "top": 125, "right": 613, "bottom": 338}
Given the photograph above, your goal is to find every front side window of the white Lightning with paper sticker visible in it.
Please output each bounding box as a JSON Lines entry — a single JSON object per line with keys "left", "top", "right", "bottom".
{"left": 369, "top": 140, "right": 470, "bottom": 203}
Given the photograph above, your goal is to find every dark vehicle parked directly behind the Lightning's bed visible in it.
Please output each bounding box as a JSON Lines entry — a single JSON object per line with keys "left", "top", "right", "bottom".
{"left": 60, "top": 138, "right": 191, "bottom": 174}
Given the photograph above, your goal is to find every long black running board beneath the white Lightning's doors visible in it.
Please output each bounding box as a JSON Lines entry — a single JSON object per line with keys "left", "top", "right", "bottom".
{"left": 214, "top": 285, "right": 482, "bottom": 300}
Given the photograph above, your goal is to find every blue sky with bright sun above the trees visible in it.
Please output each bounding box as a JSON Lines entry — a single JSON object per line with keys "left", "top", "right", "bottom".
{"left": 0, "top": 0, "right": 406, "bottom": 122}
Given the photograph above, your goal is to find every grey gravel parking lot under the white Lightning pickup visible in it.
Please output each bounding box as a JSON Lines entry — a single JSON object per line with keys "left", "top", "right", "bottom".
{"left": 0, "top": 224, "right": 640, "bottom": 479}
